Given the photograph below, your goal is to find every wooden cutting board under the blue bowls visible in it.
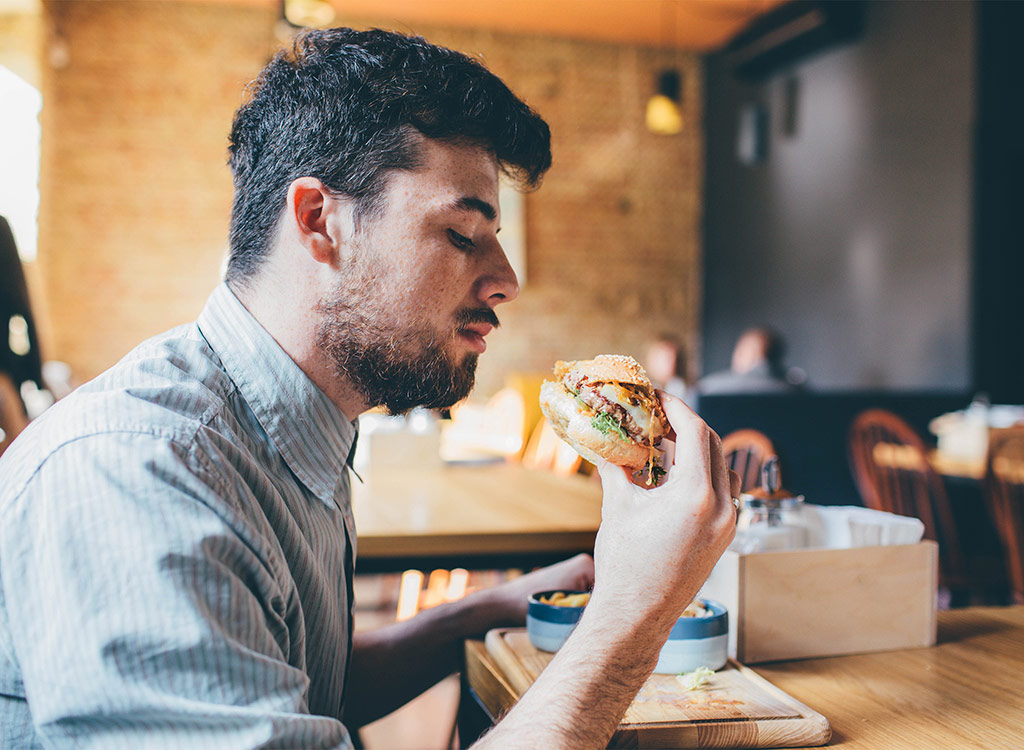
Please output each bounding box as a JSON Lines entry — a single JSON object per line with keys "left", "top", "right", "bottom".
{"left": 484, "top": 628, "right": 831, "bottom": 748}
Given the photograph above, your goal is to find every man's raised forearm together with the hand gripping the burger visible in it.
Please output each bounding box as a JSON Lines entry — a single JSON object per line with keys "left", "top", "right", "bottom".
{"left": 474, "top": 398, "right": 739, "bottom": 750}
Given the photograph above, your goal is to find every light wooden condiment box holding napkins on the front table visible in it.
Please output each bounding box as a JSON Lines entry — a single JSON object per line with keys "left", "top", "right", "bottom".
{"left": 700, "top": 540, "right": 938, "bottom": 664}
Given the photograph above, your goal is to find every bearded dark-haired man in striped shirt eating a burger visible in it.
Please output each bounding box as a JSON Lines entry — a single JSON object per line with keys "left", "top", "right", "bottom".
{"left": 0, "top": 30, "right": 736, "bottom": 748}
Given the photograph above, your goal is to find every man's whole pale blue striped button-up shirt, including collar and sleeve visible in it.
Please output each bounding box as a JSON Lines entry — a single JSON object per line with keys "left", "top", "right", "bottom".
{"left": 0, "top": 285, "right": 355, "bottom": 750}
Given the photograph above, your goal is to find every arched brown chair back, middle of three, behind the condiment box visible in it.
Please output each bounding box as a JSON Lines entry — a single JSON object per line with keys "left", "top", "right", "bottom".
{"left": 847, "top": 409, "right": 964, "bottom": 581}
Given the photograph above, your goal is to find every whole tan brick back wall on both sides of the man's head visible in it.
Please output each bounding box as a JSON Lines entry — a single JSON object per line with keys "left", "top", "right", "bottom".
{"left": 39, "top": 0, "right": 702, "bottom": 395}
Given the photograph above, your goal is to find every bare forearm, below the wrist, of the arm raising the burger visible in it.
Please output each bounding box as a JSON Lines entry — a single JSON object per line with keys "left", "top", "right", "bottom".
{"left": 473, "top": 602, "right": 671, "bottom": 750}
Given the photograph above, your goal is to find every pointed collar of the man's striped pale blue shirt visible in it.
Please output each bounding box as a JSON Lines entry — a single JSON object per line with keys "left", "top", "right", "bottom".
{"left": 197, "top": 284, "right": 356, "bottom": 506}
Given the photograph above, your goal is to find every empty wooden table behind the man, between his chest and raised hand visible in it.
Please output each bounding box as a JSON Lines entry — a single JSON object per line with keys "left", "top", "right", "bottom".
{"left": 352, "top": 463, "right": 601, "bottom": 572}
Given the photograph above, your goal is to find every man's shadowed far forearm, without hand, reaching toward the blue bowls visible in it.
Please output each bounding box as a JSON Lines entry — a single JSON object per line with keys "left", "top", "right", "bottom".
{"left": 344, "top": 590, "right": 512, "bottom": 726}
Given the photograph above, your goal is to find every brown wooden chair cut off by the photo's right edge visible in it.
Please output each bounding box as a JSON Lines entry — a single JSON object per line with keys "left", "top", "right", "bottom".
{"left": 984, "top": 426, "right": 1024, "bottom": 605}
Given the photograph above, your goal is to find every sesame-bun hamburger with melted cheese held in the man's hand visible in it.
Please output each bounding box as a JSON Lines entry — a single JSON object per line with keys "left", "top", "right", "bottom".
{"left": 541, "top": 355, "right": 669, "bottom": 469}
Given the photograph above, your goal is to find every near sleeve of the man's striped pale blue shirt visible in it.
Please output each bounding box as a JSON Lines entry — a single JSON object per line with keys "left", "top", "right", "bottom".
{"left": 0, "top": 433, "right": 350, "bottom": 750}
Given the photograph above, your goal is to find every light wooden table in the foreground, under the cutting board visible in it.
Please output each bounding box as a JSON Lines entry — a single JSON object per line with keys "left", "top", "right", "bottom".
{"left": 462, "top": 607, "right": 1024, "bottom": 750}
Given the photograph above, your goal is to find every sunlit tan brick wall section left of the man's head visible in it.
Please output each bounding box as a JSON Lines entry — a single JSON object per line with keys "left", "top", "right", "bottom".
{"left": 39, "top": 0, "right": 273, "bottom": 379}
